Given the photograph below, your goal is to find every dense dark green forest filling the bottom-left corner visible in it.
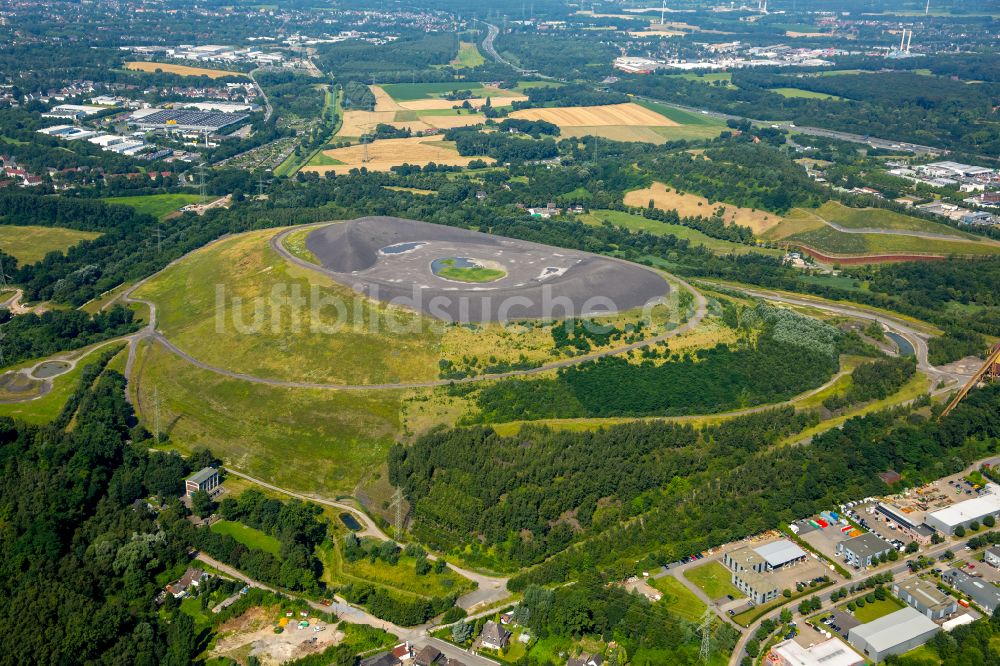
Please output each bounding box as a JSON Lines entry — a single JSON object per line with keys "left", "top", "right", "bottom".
{"left": 0, "top": 364, "right": 208, "bottom": 666}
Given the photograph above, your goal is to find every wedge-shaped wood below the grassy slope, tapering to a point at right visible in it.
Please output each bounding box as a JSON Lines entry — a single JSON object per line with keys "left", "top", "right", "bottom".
{"left": 389, "top": 408, "right": 815, "bottom": 566}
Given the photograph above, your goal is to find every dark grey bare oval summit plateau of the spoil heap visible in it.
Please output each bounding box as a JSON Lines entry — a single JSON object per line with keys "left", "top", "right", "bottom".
{"left": 306, "top": 217, "right": 670, "bottom": 322}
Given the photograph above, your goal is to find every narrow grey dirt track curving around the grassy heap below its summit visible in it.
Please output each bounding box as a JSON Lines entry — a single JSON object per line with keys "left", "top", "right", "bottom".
{"left": 120, "top": 222, "right": 708, "bottom": 391}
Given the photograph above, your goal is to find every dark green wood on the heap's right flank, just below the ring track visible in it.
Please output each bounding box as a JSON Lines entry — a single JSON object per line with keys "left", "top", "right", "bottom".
{"left": 476, "top": 304, "right": 841, "bottom": 423}
